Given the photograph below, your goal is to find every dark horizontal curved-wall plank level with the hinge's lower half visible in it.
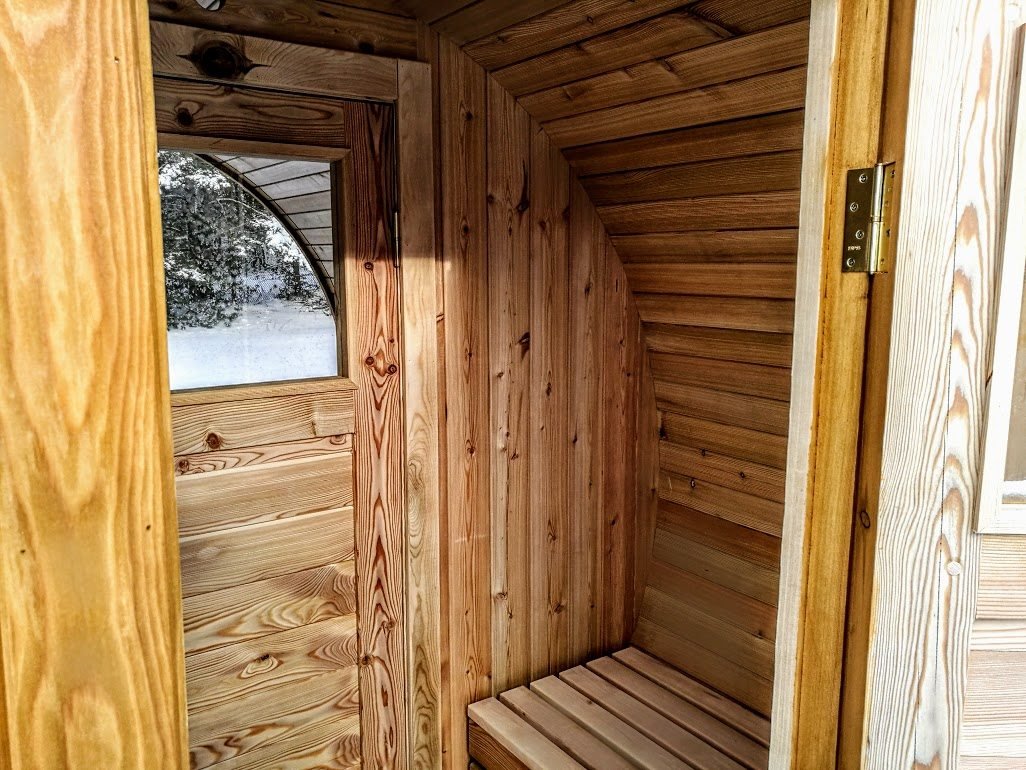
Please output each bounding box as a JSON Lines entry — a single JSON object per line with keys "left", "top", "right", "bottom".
{"left": 613, "top": 228, "right": 798, "bottom": 264}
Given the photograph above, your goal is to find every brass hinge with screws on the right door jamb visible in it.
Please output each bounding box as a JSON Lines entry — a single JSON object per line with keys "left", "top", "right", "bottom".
{"left": 840, "top": 162, "right": 898, "bottom": 275}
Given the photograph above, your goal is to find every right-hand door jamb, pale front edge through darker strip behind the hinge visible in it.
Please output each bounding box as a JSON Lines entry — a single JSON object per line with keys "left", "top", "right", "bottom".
{"left": 770, "top": 0, "right": 914, "bottom": 770}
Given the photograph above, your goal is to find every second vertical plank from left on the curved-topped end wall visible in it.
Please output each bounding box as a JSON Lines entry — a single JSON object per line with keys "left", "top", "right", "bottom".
{"left": 487, "top": 78, "right": 536, "bottom": 692}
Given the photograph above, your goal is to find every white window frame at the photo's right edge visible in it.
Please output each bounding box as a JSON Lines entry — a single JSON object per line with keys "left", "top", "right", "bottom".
{"left": 976, "top": 27, "right": 1026, "bottom": 535}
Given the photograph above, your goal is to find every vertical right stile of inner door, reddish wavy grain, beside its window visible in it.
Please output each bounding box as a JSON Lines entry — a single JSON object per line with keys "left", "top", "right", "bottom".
{"left": 345, "top": 103, "right": 409, "bottom": 767}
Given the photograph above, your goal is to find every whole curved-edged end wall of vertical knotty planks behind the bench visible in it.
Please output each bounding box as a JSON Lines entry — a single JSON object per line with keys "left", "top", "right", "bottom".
{"left": 435, "top": 39, "right": 656, "bottom": 767}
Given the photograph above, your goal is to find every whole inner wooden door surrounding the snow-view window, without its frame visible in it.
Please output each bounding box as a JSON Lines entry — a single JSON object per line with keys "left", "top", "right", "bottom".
{"left": 155, "top": 64, "right": 405, "bottom": 770}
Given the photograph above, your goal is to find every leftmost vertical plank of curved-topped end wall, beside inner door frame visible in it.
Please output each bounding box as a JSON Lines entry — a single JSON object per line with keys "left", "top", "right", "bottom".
{"left": 437, "top": 40, "right": 491, "bottom": 767}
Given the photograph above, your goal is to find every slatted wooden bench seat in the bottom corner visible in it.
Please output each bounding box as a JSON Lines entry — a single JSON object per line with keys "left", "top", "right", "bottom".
{"left": 468, "top": 647, "right": 770, "bottom": 770}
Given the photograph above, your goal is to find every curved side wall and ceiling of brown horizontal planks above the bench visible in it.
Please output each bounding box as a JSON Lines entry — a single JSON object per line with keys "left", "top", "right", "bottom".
{"left": 422, "top": 0, "right": 810, "bottom": 714}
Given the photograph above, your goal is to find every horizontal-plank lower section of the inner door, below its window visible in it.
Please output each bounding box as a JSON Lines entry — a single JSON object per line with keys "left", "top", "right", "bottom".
{"left": 171, "top": 379, "right": 361, "bottom": 770}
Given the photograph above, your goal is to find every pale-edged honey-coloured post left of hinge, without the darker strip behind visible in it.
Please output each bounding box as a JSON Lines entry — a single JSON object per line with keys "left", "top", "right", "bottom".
{"left": 770, "top": 0, "right": 889, "bottom": 770}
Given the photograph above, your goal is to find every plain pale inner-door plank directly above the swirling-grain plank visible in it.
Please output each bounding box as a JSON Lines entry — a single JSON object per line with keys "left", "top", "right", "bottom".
{"left": 181, "top": 508, "right": 354, "bottom": 596}
